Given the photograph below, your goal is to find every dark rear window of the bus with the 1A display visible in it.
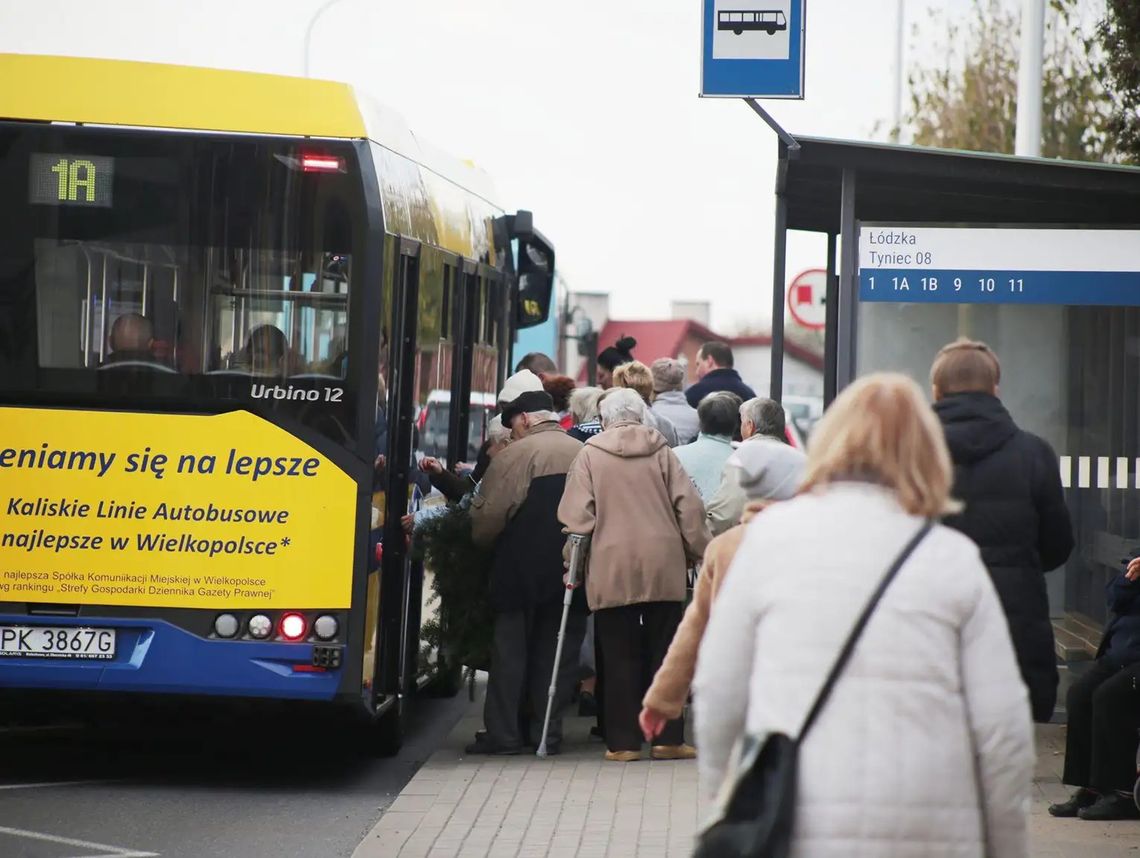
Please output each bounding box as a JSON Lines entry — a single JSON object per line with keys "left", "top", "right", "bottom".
{"left": 0, "top": 123, "right": 364, "bottom": 397}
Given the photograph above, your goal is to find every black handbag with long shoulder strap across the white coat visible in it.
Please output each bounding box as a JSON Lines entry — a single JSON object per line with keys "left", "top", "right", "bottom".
{"left": 693, "top": 522, "right": 933, "bottom": 858}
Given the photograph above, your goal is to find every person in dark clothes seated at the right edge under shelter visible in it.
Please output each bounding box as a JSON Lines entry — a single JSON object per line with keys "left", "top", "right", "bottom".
{"left": 1049, "top": 557, "right": 1140, "bottom": 822}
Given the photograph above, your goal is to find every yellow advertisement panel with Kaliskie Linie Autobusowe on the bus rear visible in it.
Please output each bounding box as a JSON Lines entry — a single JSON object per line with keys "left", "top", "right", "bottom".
{"left": 0, "top": 408, "right": 356, "bottom": 608}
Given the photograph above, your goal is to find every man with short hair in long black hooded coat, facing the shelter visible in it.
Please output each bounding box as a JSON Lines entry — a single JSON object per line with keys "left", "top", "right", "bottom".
{"left": 930, "top": 340, "right": 1073, "bottom": 722}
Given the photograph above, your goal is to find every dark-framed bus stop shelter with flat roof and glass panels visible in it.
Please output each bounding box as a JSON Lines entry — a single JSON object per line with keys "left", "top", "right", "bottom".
{"left": 772, "top": 138, "right": 1140, "bottom": 637}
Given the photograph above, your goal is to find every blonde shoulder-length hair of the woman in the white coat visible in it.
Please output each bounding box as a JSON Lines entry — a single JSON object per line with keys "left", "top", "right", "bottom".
{"left": 804, "top": 373, "right": 961, "bottom": 518}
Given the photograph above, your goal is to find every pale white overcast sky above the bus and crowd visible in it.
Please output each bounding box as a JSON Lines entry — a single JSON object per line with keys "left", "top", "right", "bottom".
{"left": 0, "top": 0, "right": 1096, "bottom": 334}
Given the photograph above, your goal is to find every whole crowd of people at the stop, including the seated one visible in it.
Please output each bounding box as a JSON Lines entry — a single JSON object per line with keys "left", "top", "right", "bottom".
{"left": 405, "top": 338, "right": 1140, "bottom": 856}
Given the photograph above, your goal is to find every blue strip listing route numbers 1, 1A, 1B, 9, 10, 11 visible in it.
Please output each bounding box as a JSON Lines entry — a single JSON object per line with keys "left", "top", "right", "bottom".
{"left": 858, "top": 268, "right": 1140, "bottom": 307}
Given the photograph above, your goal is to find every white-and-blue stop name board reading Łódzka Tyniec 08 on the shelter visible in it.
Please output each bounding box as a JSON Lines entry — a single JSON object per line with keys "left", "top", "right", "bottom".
{"left": 858, "top": 223, "right": 1140, "bottom": 307}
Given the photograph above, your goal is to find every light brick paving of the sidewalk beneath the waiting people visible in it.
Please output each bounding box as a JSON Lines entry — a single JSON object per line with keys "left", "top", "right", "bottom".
{"left": 353, "top": 692, "right": 1140, "bottom": 858}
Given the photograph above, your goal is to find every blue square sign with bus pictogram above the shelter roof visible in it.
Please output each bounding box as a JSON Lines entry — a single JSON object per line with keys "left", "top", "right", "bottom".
{"left": 701, "top": 0, "right": 807, "bottom": 98}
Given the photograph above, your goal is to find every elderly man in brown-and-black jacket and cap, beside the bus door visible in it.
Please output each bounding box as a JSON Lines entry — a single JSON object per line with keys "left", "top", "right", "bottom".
{"left": 467, "top": 369, "right": 586, "bottom": 754}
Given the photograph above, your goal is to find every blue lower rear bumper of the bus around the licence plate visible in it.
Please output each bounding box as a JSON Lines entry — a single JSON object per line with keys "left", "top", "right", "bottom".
{"left": 0, "top": 614, "right": 342, "bottom": 701}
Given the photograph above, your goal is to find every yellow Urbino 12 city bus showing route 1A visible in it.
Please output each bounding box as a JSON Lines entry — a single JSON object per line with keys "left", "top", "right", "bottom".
{"left": 0, "top": 55, "right": 554, "bottom": 749}
